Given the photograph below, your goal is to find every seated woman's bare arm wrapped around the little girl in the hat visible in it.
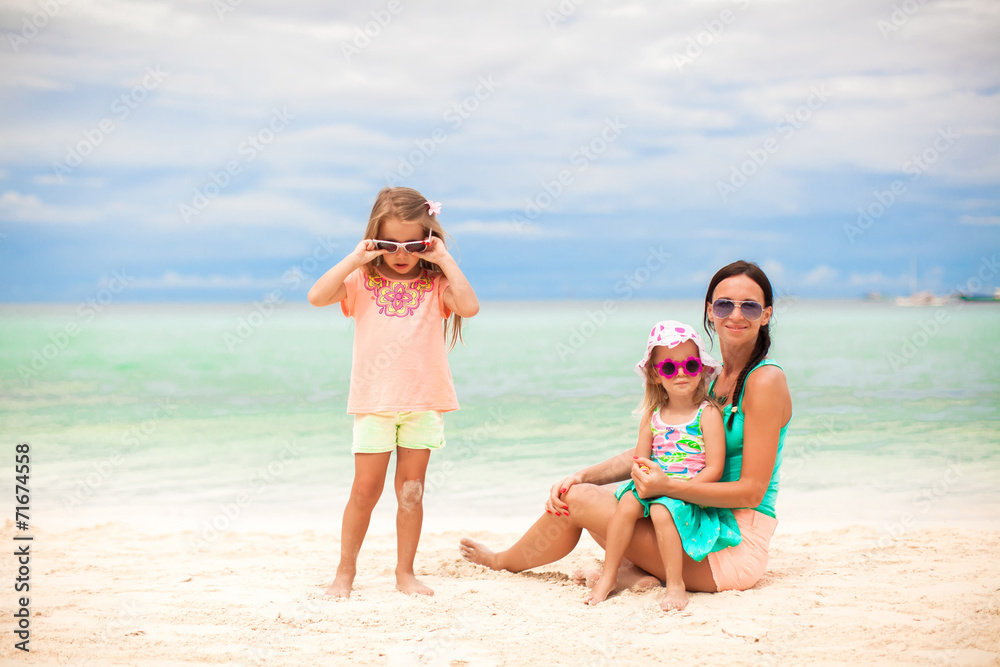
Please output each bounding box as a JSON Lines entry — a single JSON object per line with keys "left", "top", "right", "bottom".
{"left": 632, "top": 366, "right": 792, "bottom": 508}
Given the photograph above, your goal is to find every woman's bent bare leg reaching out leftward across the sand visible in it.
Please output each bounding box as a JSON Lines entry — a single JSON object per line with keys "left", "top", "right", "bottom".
{"left": 461, "top": 484, "right": 618, "bottom": 572}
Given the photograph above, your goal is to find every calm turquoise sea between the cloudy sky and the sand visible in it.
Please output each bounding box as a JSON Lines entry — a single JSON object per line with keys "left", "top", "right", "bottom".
{"left": 0, "top": 301, "right": 1000, "bottom": 544}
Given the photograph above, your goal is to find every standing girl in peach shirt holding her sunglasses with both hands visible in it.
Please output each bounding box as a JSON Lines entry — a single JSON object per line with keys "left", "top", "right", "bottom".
{"left": 309, "top": 187, "right": 479, "bottom": 598}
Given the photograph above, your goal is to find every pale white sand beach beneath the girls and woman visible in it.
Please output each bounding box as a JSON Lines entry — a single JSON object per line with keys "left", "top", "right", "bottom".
{"left": 0, "top": 522, "right": 1000, "bottom": 665}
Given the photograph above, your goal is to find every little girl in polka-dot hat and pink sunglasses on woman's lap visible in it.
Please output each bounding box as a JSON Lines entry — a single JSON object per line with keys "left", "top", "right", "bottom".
{"left": 586, "top": 320, "right": 741, "bottom": 610}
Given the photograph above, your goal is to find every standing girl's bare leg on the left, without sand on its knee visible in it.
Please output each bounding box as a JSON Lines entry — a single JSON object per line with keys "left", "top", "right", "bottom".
{"left": 325, "top": 452, "right": 390, "bottom": 598}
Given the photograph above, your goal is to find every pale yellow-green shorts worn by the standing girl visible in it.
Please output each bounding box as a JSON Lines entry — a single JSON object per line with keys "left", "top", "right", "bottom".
{"left": 351, "top": 410, "right": 444, "bottom": 454}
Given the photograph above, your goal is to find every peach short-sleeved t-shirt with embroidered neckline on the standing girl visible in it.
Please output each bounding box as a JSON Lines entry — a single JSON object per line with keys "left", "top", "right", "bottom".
{"left": 340, "top": 269, "right": 458, "bottom": 414}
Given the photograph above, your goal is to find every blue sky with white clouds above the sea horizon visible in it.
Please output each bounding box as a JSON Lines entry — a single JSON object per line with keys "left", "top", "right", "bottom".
{"left": 0, "top": 0, "right": 1000, "bottom": 303}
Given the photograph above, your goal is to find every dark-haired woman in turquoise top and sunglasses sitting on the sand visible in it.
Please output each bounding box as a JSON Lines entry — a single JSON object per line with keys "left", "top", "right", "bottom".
{"left": 461, "top": 261, "right": 792, "bottom": 592}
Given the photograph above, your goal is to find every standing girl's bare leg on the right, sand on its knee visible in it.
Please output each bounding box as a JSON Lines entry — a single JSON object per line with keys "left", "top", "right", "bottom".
{"left": 395, "top": 447, "right": 434, "bottom": 595}
